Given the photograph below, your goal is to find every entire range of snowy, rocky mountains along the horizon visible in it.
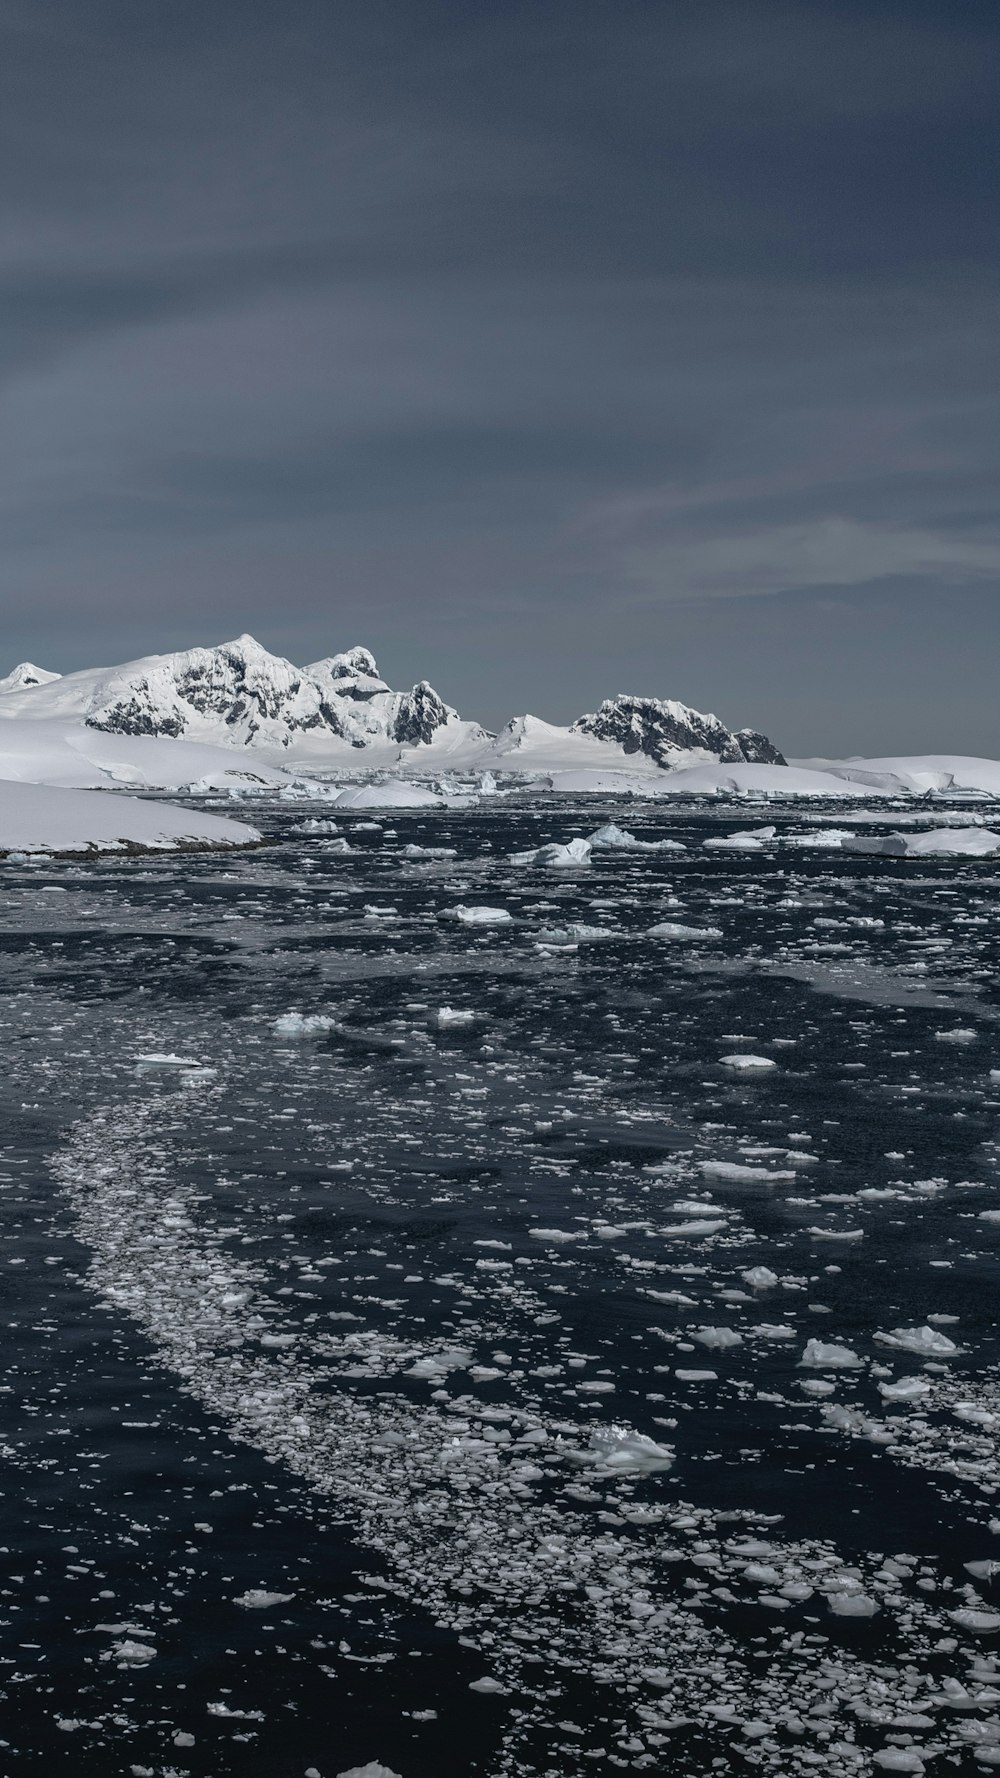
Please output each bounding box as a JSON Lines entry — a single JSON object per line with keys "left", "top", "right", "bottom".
{"left": 0, "top": 635, "right": 785, "bottom": 772}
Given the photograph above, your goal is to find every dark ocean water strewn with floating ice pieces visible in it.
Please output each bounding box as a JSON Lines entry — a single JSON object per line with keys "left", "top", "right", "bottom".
{"left": 0, "top": 798, "right": 1000, "bottom": 1778}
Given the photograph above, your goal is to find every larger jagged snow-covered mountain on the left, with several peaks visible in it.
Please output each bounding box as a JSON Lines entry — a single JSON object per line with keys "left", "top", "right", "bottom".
{"left": 0, "top": 637, "right": 488, "bottom": 750}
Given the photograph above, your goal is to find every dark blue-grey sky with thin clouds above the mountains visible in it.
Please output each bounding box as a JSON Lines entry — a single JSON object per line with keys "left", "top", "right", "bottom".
{"left": 0, "top": 0, "right": 1000, "bottom": 756}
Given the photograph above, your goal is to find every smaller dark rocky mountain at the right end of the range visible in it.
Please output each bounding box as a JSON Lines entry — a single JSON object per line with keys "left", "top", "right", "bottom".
{"left": 571, "top": 693, "right": 785, "bottom": 770}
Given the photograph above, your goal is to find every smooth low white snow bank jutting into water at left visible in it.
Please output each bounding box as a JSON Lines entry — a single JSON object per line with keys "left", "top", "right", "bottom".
{"left": 0, "top": 782, "right": 262, "bottom": 852}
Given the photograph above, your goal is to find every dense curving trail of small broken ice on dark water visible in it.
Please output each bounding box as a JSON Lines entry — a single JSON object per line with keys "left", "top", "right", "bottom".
{"left": 53, "top": 1086, "right": 1000, "bottom": 1778}
